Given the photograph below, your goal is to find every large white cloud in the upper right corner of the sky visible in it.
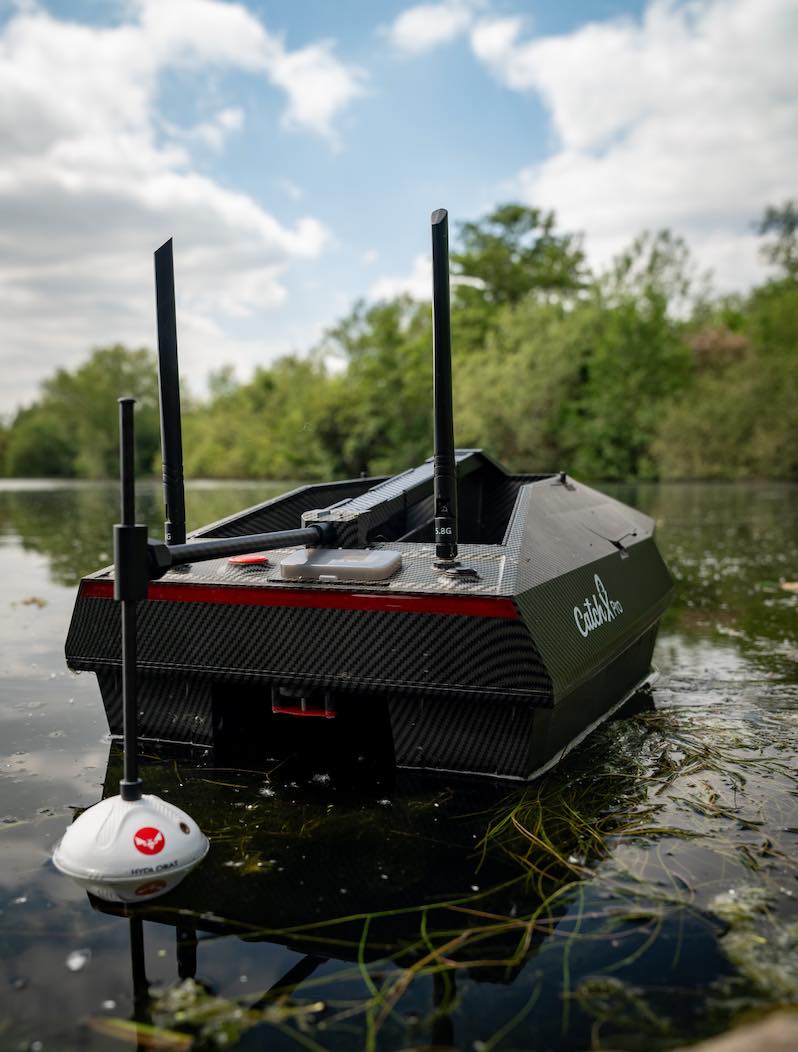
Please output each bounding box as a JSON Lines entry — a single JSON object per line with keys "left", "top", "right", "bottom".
{"left": 471, "top": 0, "right": 798, "bottom": 287}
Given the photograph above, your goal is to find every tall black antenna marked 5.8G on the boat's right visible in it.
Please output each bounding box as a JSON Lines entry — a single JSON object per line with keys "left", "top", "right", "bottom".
{"left": 431, "top": 208, "right": 457, "bottom": 566}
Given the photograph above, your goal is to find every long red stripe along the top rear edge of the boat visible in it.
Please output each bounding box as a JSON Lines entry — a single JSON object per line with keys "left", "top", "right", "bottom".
{"left": 79, "top": 580, "right": 518, "bottom": 621}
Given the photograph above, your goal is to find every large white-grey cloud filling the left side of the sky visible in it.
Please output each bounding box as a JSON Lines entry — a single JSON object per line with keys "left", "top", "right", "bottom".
{"left": 0, "top": 0, "right": 360, "bottom": 411}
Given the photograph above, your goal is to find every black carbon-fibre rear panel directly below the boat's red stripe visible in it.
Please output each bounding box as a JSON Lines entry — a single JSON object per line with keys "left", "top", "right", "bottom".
{"left": 66, "top": 598, "right": 551, "bottom": 704}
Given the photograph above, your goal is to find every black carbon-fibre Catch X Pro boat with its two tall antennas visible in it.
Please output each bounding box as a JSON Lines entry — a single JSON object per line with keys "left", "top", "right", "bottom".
{"left": 66, "top": 209, "right": 672, "bottom": 780}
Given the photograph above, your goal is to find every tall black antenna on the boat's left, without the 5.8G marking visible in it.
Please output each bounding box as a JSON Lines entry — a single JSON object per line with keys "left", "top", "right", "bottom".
{"left": 156, "top": 238, "right": 186, "bottom": 544}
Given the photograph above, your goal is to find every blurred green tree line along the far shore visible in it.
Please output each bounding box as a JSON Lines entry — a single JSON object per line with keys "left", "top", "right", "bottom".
{"left": 0, "top": 201, "right": 798, "bottom": 480}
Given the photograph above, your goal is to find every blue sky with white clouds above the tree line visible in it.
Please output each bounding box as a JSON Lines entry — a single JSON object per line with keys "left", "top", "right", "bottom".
{"left": 0, "top": 0, "right": 798, "bottom": 418}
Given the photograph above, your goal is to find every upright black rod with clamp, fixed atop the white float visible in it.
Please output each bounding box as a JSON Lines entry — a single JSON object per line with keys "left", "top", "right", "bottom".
{"left": 114, "top": 398, "right": 147, "bottom": 801}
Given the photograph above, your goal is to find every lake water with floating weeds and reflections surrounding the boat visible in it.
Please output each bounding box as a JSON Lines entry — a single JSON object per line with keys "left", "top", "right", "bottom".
{"left": 0, "top": 482, "right": 798, "bottom": 1052}
